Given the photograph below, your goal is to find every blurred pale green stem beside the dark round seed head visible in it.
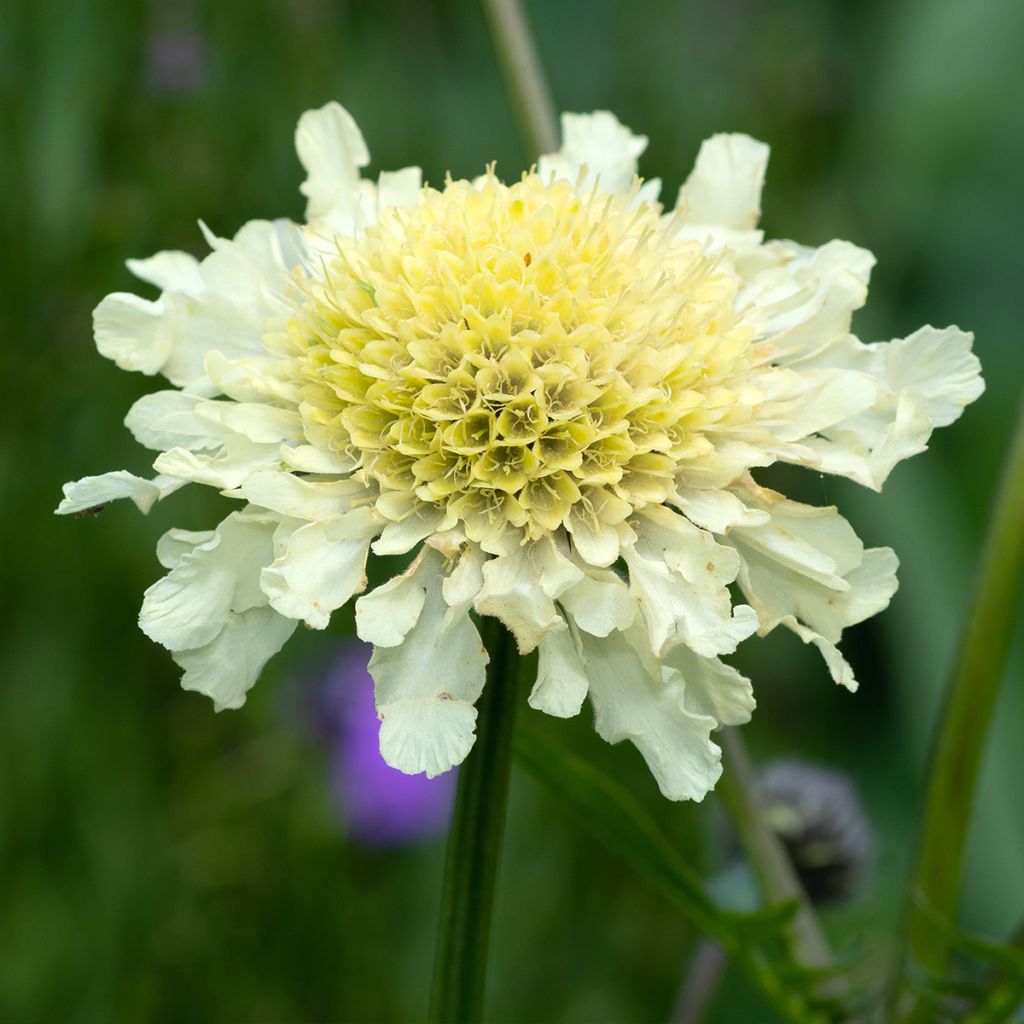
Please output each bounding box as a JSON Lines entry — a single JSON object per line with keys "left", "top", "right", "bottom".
{"left": 715, "top": 728, "right": 833, "bottom": 968}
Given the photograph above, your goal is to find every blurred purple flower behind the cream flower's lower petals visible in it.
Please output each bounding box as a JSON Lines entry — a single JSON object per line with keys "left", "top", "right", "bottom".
{"left": 316, "top": 643, "right": 456, "bottom": 847}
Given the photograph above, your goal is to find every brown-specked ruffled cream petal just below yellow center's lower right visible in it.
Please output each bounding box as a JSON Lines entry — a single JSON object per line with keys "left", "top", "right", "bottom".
{"left": 624, "top": 506, "right": 758, "bottom": 657}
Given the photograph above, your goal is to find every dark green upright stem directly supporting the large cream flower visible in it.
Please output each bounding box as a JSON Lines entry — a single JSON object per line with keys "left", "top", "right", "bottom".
{"left": 429, "top": 617, "right": 519, "bottom": 1024}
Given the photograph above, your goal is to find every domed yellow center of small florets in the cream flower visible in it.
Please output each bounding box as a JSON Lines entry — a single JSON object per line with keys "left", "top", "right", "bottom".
{"left": 288, "top": 173, "right": 752, "bottom": 540}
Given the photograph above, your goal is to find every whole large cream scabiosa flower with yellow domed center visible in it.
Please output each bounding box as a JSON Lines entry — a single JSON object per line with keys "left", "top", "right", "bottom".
{"left": 58, "top": 103, "right": 982, "bottom": 800}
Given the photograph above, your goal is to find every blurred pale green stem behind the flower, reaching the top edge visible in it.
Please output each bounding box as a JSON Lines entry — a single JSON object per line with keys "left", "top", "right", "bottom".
{"left": 483, "top": 0, "right": 558, "bottom": 158}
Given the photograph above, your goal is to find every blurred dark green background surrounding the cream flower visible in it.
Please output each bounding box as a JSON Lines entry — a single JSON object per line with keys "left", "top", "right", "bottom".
{"left": 0, "top": 0, "right": 1024, "bottom": 1022}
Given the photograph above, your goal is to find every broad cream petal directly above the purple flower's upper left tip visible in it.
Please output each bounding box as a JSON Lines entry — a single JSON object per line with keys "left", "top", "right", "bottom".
{"left": 260, "top": 508, "right": 381, "bottom": 630}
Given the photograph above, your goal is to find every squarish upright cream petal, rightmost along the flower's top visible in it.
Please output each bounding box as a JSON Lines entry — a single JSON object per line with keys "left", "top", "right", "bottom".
{"left": 676, "top": 134, "right": 768, "bottom": 230}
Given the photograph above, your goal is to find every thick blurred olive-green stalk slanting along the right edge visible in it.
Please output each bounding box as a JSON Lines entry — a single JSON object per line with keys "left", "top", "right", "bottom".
{"left": 892, "top": 404, "right": 1024, "bottom": 1022}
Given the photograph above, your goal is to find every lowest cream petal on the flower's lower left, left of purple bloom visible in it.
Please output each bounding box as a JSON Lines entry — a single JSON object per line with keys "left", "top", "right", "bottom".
{"left": 173, "top": 608, "right": 298, "bottom": 711}
